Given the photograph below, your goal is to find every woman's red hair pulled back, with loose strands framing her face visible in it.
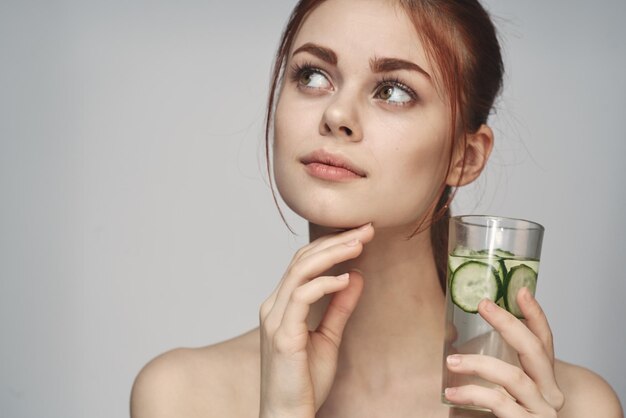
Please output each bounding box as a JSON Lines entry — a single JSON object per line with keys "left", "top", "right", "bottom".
{"left": 265, "top": 0, "right": 504, "bottom": 288}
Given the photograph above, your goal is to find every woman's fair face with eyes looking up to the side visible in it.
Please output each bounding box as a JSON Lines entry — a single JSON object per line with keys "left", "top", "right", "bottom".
{"left": 274, "top": 0, "right": 451, "bottom": 232}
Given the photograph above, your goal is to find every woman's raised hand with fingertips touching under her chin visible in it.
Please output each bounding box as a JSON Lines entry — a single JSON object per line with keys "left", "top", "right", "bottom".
{"left": 260, "top": 224, "right": 374, "bottom": 418}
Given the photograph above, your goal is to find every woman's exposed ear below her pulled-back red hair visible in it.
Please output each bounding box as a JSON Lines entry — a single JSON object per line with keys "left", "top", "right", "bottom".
{"left": 446, "top": 124, "right": 493, "bottom": 187}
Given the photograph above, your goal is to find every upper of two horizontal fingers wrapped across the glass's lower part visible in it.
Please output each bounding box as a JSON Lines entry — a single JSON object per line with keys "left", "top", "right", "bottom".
{"left": 446, "top": 354, "right": 552, "bottom": 416}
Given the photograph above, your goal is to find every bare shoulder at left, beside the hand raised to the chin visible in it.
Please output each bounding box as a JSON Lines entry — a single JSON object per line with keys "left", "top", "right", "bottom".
{"left": 131, "top": 329, "right": 260, "bottom": 418}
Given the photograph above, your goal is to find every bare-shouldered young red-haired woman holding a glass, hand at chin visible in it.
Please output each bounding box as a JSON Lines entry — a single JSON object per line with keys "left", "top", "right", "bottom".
{"left": 131, "top": 0, "right": 623, "bottom": 418}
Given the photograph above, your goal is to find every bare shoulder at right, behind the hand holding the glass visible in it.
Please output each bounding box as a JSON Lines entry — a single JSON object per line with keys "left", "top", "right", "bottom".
{"left": 555, "top": 360, "right": 624, "bottom": 418}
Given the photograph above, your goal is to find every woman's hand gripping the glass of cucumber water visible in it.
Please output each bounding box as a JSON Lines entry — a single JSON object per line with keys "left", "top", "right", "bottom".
{"left": 446, "top": 288, "right": 565, "bottom": 418}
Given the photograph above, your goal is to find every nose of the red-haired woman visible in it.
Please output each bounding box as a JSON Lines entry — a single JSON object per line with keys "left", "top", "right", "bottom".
{"left": 320, "top": 93, "right": 363, "bottom": 142}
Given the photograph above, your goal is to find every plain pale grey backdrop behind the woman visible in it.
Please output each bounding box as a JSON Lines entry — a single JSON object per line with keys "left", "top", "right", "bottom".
{"left": 0, "top": 0, "right": 626, "bottom": 418}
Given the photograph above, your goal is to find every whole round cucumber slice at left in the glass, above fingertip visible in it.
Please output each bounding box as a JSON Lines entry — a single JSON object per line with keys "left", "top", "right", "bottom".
{"left": 450, "top": 261, "right": 502, "bottom": 313}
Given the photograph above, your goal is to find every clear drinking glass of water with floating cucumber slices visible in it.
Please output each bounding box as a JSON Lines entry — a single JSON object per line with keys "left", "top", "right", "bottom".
{"left": 441, "top": 215, "right": 544, "bottom": 409}
